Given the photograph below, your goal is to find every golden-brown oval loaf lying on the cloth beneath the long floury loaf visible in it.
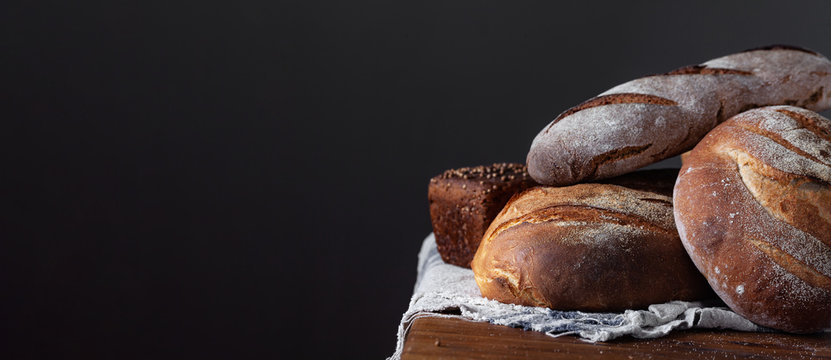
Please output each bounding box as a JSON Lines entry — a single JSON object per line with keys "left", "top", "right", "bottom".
{"left": 471, "top": 170, "right": 715, "bottom": 311}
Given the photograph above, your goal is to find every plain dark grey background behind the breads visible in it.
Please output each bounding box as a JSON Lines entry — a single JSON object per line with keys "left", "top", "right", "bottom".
{"left": 0, "top": 0, "right": 831, "bottom": 359}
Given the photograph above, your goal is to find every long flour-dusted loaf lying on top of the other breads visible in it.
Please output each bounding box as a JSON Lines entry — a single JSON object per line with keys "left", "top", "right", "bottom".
{"left": 527, "top": 46, "right": 831, "bottom": 185}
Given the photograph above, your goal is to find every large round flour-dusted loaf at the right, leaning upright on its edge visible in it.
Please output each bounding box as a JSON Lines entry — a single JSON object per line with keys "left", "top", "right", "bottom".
{"left": 674, "top": 106, "right": 831, "bottom": 333}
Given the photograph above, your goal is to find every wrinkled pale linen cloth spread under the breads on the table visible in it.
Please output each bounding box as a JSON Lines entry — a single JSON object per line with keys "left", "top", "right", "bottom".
{"left": 389, "top": 234, "right": 772, "bottom": 360}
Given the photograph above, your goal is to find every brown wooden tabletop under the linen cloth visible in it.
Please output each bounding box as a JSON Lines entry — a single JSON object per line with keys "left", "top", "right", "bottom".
{"left": 401, "top": 317, "right": 831, "bottom": 360}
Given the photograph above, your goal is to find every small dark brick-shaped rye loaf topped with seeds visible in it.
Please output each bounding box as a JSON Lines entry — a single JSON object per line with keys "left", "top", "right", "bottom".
{"left": 427, "top": 163, "right": 537, "bottom": 267}
